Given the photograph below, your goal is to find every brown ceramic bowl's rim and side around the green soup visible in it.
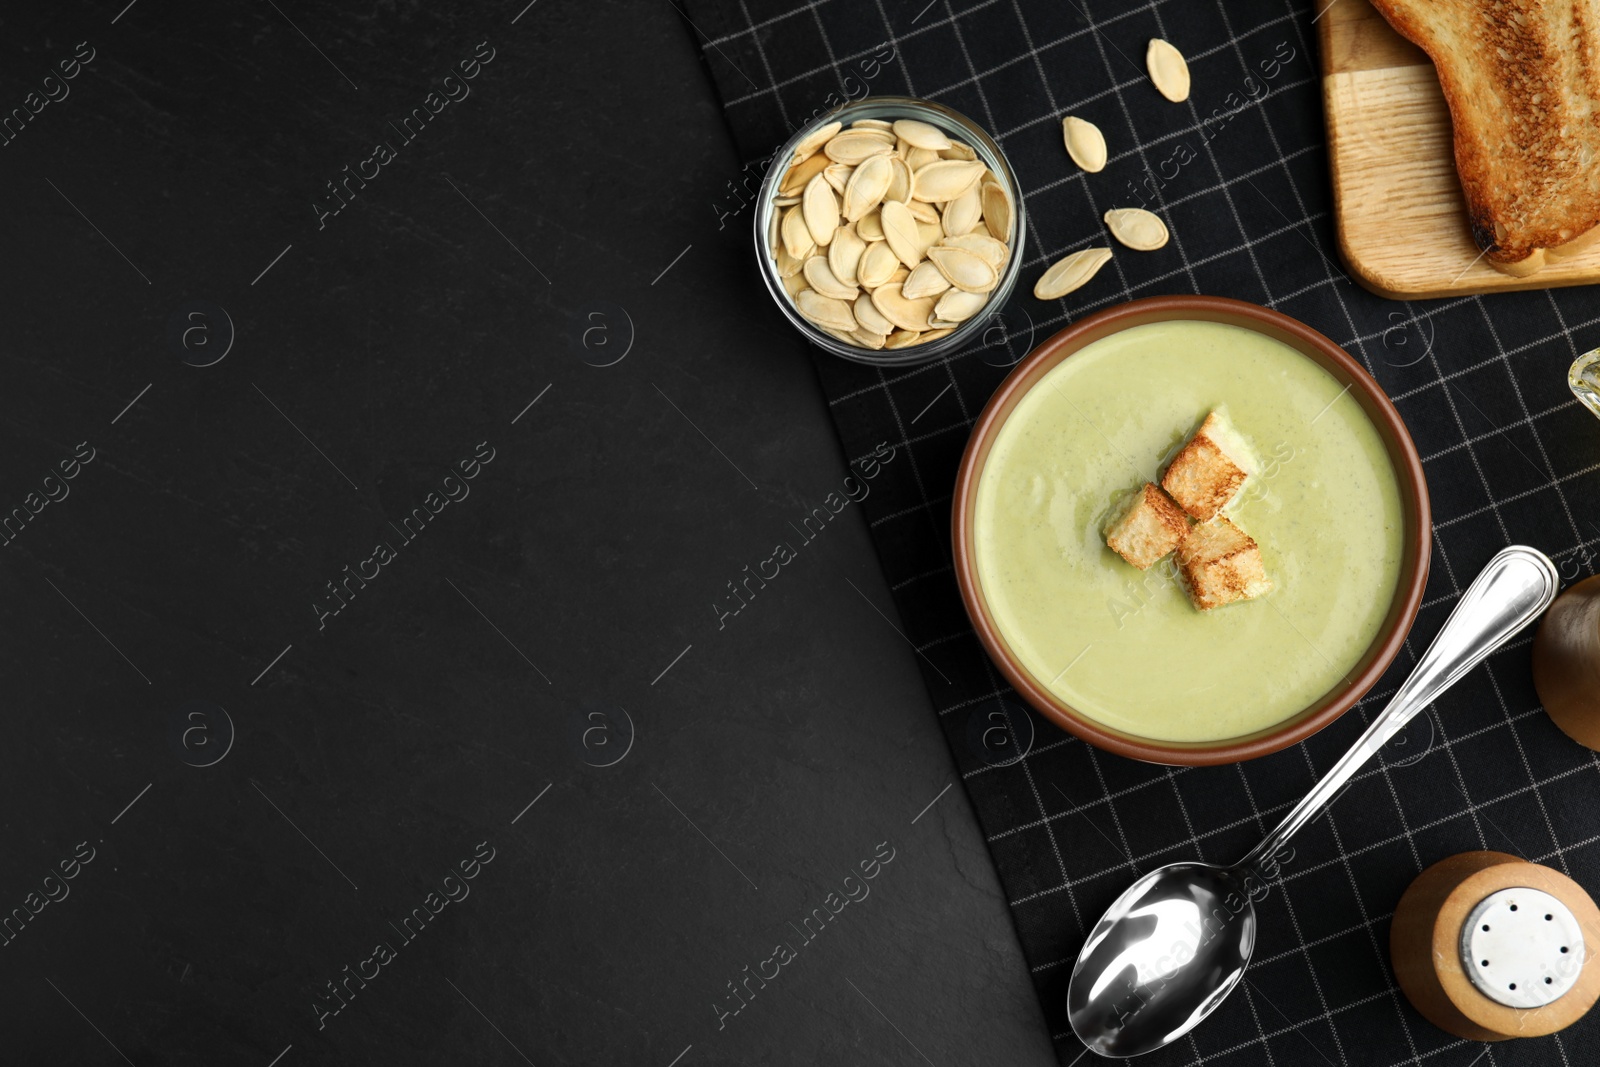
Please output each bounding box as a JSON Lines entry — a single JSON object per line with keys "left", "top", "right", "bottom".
{"left": 952, "top": 296, "right": 1432, "bottom": 766}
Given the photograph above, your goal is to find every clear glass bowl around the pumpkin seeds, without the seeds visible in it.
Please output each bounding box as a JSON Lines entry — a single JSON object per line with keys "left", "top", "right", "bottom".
{"left": 755, "top": 96, "right": 1027, "bottom": 366}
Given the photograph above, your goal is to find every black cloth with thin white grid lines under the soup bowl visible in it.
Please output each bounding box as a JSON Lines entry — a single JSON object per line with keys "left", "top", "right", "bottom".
{"left": 690, "top": 0, "right": 1600, "bottom": 1067}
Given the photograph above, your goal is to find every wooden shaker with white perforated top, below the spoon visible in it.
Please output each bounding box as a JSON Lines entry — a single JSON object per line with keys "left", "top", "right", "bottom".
{"left": 1389, "top": 853, "right": 1600, "bottom": 1041}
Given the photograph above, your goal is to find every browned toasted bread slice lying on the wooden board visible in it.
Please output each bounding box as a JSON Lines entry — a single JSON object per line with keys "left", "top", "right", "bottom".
{"left": 1371, "top": 0, "right": 1600, "bottom": 275}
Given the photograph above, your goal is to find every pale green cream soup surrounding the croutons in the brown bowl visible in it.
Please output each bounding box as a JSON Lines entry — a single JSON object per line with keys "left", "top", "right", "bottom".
{"left": 973, "top": 322, "right": 1403, "bottom": 741}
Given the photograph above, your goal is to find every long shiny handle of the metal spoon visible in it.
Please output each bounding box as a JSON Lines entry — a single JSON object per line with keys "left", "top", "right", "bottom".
{"left": 1240, "top": 545, "right": 1558, "bottom": 870}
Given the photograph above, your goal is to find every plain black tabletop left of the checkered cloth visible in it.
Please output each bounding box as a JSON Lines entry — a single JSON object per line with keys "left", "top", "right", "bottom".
{"left": 0, "top": 0, "right": 1051, "bottom": 1067}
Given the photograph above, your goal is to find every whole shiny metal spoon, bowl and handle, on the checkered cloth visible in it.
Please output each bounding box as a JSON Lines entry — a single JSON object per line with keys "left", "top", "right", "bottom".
{"left": 1067, "top": 545, "right": 1558, "bottom": 1057}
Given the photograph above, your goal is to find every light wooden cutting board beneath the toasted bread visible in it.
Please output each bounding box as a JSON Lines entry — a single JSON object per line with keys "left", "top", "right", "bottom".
{"left": 1317, "top": 0, "right": 1600, "bottom": 299}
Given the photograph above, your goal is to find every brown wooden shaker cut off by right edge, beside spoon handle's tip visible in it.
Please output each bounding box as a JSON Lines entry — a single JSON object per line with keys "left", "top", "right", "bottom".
{"left": 1533, "top": 576, "right": 1600, "bottom": 750}
